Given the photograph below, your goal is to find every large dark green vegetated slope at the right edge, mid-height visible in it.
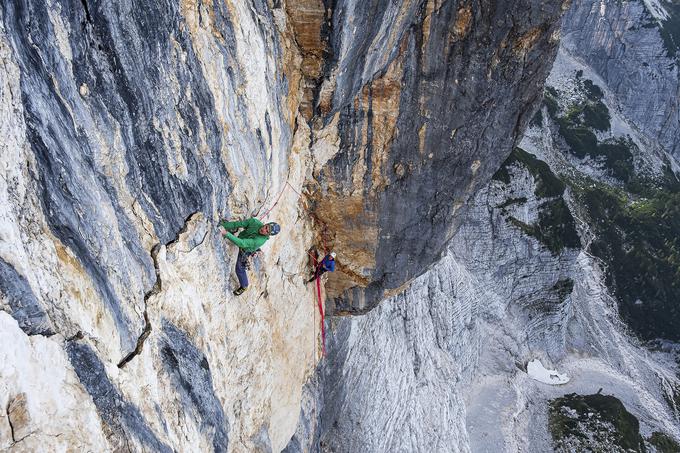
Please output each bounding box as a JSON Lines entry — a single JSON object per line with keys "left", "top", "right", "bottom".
{"left": 574, "top": 177, "right": 680, "bottom": 341}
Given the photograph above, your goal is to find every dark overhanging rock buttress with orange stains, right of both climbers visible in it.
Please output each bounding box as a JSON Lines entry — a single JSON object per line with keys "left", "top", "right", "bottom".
{"left": 314, "top": 0, "right": 562, "bottom": 313}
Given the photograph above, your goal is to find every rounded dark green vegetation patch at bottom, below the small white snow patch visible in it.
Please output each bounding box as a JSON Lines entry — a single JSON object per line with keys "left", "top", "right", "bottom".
{"left": 548, "top": 393, "right": 645, "bottom": 452}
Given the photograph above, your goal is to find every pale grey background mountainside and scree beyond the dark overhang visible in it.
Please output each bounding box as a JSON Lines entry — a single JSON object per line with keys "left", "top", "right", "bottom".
{"left": 286, "top": 1, "right": 680, "bottom": 452}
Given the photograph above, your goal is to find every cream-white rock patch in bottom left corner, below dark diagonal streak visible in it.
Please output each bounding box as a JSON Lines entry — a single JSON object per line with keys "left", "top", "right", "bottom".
{"left": 0, "top": 312, "right": 109, "bottom": 451}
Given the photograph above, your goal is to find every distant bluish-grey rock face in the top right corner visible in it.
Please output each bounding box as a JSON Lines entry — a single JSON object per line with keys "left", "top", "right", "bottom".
{"left": 562, "top": 0, "right": 680, "bottom": 158}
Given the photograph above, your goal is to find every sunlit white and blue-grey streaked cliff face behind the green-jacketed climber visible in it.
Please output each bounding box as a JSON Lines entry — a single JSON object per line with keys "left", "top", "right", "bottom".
{"left": 0, "top": 1, "right": 318, "bottom": 451}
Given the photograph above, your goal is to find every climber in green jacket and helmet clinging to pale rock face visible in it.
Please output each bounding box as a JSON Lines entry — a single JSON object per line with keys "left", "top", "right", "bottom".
{"left": 220, "top": 217, "right": 281, "bottom": 296}
